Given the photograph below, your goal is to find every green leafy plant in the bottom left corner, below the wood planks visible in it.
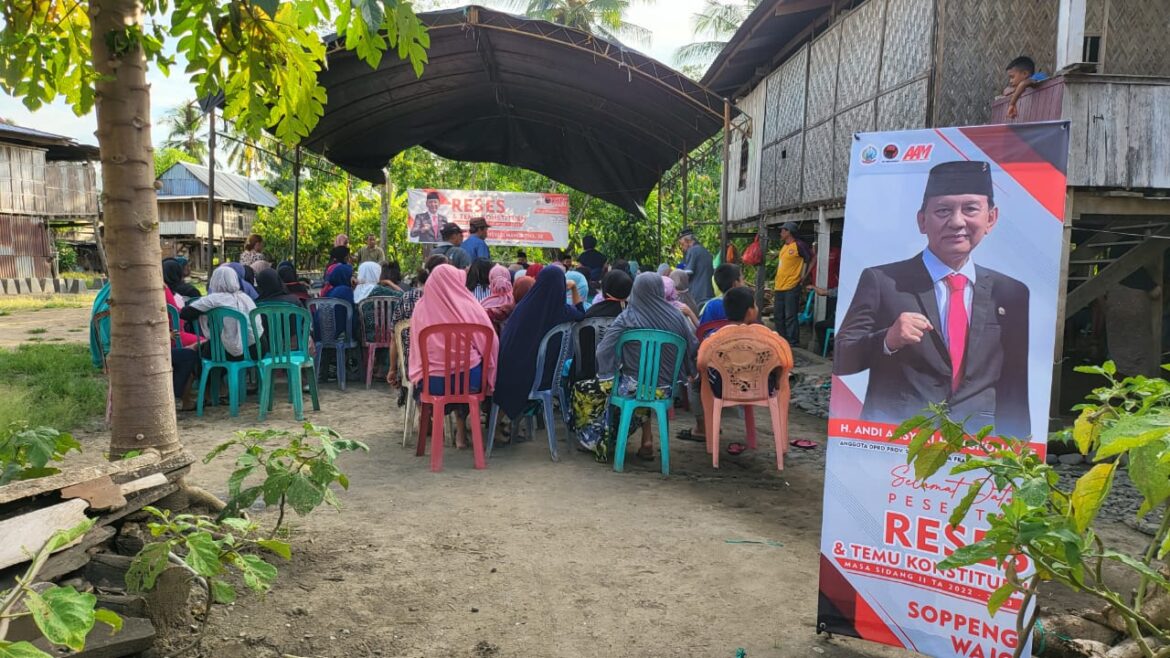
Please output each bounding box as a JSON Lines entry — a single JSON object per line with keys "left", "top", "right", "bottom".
{"left": 0, "top": 519, "right": 122, "bottom": 658}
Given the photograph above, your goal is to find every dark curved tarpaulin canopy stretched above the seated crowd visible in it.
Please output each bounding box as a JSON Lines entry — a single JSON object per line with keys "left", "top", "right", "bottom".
{"left": 302, "top": 6, "right": 723, "bottom": 214}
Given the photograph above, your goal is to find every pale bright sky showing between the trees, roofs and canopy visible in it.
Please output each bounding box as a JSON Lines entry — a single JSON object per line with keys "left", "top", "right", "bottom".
{"left": 0, "top": 0, "right": 703, "bottom": 144}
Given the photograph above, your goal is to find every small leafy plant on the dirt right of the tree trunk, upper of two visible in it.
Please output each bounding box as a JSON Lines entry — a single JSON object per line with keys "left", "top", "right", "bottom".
{"left": 204, "top": 423, "right": 370, "bottom": 535}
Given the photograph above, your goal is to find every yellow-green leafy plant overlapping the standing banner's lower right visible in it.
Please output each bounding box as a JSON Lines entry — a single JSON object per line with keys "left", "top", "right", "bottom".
{"left": 894, "top": 362, "right": 1170, "bottom": 658}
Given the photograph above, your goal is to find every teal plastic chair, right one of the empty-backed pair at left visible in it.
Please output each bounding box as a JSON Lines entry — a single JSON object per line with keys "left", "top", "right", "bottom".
{"left": 250, "top": 302, "right": 321, "bottom": 420}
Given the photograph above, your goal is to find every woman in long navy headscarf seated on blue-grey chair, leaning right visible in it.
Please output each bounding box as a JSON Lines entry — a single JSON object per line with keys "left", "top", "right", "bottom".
{"left": 493, "top": 267, "right": 585, "bottom": 440}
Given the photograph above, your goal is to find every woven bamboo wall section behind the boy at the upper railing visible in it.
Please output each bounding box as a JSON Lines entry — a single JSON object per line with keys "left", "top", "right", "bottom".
{"left": 931, "top": 0, "right": 1062, "bottom": 126}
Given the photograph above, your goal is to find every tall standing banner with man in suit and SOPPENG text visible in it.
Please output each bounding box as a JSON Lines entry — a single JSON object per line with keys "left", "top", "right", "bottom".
{"left": 818, "top": 123, "right": 1068, "bottom": 658}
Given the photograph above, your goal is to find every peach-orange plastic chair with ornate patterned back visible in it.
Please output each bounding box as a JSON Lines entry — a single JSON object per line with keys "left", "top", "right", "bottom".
{"left": 698, "top": 324, "right": 792, "bottom": 471}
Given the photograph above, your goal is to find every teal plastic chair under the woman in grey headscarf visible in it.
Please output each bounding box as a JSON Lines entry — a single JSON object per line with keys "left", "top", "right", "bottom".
{"left": 607, "top": 329, "right": 687, "bottom": 475}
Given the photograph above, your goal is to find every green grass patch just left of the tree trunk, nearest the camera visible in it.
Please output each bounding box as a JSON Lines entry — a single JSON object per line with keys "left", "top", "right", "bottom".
{"left": 0, "top": 338, "right": 105, "bottom": 432}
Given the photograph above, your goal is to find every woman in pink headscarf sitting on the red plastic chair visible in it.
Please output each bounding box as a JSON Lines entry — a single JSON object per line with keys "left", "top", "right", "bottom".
{"left": 408, "top": 265, "right": 500, "bottom": 447}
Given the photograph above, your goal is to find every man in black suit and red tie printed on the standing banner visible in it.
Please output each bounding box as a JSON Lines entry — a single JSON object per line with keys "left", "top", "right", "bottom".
{"left": 834, "top": 162, "right": 1031, "bottom": 438}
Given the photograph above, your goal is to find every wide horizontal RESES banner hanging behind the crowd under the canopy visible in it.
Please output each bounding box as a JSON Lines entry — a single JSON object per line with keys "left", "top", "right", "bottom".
{"left": 406, "top": 189, "right": 569, "bottom": 248}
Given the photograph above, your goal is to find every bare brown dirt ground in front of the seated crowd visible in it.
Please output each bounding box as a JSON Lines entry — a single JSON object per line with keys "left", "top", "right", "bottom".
{"left": 0, "top": 309, "right": 1151, "bottom": 658}
